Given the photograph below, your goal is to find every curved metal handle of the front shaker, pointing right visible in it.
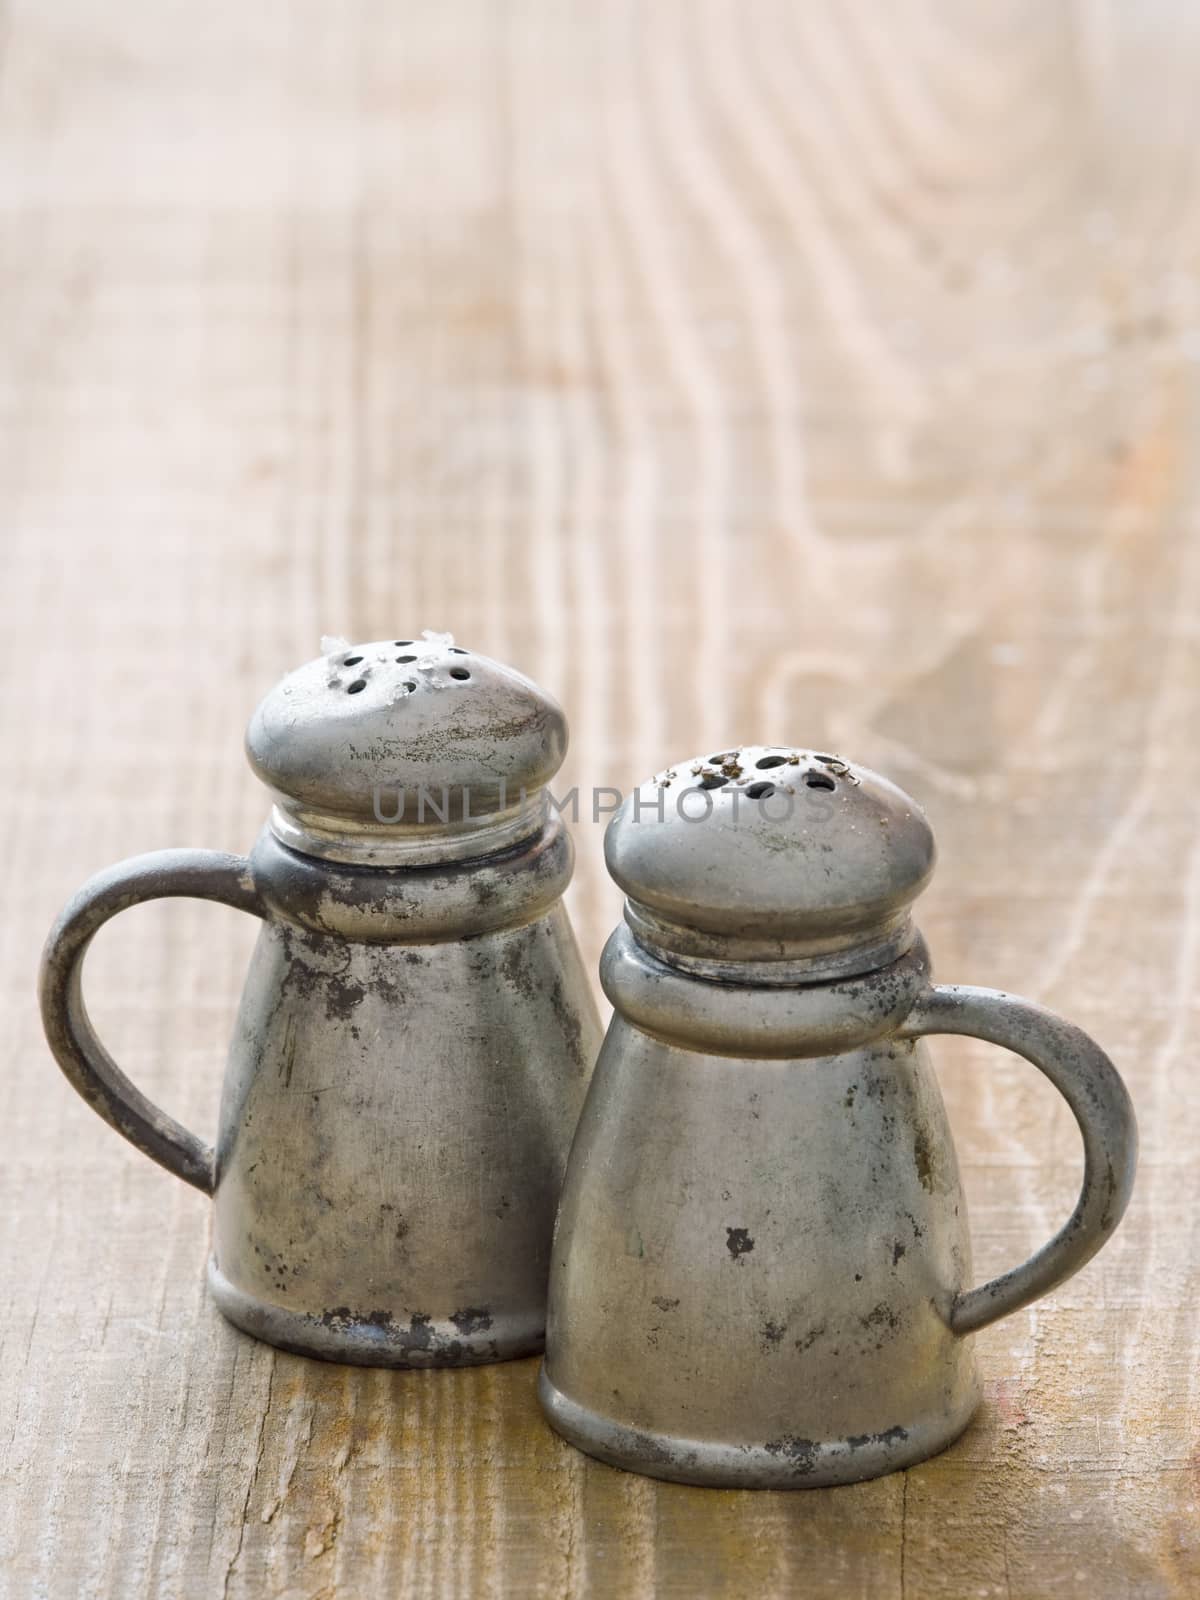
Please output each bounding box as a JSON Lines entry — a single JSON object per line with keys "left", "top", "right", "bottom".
{"left": 899, "top": 984, "right": 1138, "bottom": 1333}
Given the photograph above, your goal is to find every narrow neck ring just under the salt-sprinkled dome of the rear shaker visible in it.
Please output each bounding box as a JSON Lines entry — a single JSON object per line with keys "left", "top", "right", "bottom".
{"left": 267, "top": 790, "right": 549, "bottom": 867}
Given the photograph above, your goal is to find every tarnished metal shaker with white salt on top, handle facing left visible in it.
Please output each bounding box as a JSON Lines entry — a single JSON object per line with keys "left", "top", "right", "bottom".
{"left": 40, "top": 634, "right": 600, "bottom": 1366}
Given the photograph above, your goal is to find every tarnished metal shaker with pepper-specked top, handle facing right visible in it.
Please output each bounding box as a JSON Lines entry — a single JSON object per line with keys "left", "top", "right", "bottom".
{"left": 539, "top": 747, "right": 1136, "bottom": 1488}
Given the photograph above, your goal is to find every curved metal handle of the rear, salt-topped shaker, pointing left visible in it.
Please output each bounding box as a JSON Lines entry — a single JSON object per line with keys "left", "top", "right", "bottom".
{"left": 38, "top": 850, "right": 264, "bottom": 1194}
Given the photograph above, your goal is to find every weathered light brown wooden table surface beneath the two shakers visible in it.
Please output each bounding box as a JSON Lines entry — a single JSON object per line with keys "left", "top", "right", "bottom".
{"left": 0, "top": 0, "right": 1200, "bottom": 1600}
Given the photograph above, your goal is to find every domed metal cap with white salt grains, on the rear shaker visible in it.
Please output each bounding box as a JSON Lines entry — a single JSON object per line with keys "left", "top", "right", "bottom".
{"left": 246, "top": 630, "right": 566, "bottom": 866}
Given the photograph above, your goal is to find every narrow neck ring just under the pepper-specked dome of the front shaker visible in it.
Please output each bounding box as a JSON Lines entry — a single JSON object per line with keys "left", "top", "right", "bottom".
{"left": 624, "top": 899, "right": 917, "bottom": 987}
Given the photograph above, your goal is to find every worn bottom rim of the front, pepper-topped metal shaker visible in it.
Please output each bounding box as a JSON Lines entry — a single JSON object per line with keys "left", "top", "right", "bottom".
{"left": 538, "top": 1363, "right": 981, "bottom": 1490}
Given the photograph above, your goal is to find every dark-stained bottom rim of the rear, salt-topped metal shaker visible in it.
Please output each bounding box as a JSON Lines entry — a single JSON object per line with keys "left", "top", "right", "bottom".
{"left": 208, "top": 1256, "right": 546, "bottom": 1371}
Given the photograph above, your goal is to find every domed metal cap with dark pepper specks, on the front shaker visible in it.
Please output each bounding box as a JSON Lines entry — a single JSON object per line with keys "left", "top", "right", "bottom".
{"left": 605, "top": 746, "right": 934, "bottom": 982}
